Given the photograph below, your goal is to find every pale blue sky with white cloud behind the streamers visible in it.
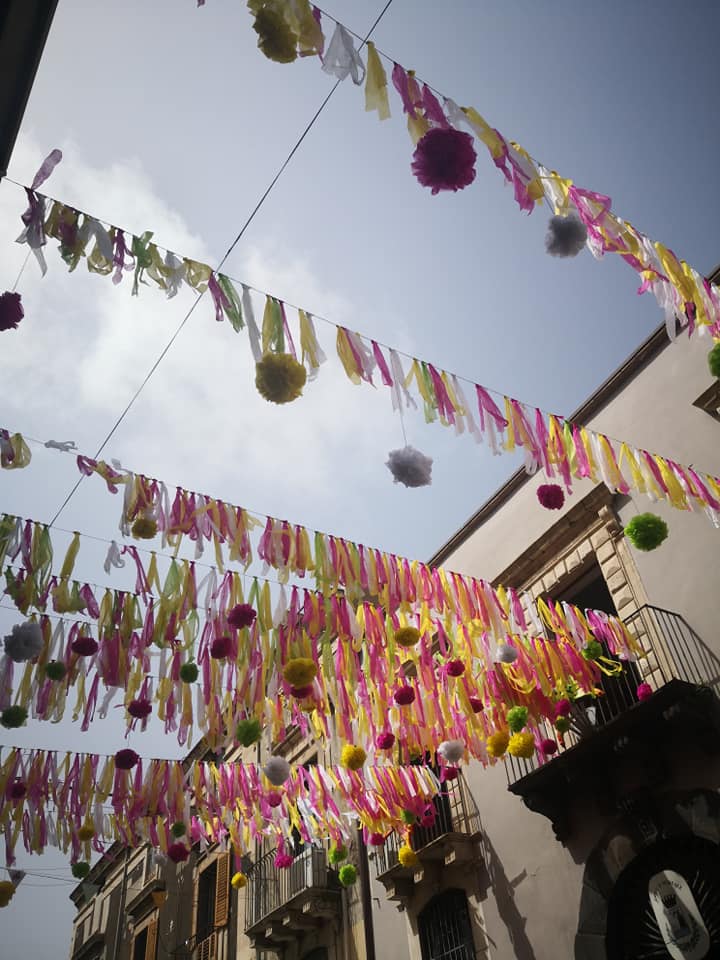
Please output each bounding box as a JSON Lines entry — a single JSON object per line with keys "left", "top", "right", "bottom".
{"left": 0, "top": 0, "right": 720, "bottom": 960}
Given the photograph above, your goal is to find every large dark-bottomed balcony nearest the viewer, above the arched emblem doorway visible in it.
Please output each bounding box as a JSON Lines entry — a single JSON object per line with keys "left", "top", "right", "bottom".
{"left": 506, "top": 605, "right": 720, "bottom": 842}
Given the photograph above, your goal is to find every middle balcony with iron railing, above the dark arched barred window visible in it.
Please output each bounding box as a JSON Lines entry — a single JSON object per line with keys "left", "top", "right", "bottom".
{"left": 371, "top": 774, "right": 480, "bottom": 904}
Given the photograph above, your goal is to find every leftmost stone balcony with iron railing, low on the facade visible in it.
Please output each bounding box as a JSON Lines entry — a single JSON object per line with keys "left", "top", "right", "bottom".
{"left": 245, "top": 847, "right": 340, "bottom": 950}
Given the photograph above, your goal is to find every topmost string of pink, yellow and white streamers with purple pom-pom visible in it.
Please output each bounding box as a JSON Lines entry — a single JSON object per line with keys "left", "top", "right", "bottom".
{"left": 204, "top": 0, "right": 720, "bottom": 340}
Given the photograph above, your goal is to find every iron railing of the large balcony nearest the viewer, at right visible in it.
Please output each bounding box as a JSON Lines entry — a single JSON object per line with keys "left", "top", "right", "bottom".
{"left": 506, "top": 604, "right": 720, "bottom": 783}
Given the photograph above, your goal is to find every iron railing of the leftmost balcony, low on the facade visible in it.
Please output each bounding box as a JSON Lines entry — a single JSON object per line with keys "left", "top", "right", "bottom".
{"left": 245, "top": 847, "right": 330, "bottom": 930}
